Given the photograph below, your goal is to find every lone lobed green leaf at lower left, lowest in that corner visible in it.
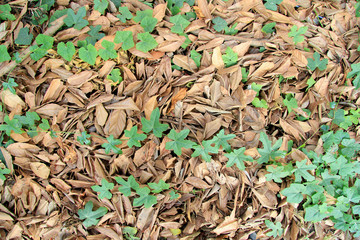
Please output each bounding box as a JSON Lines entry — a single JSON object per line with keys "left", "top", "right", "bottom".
{"left": 78, "top": 201, "right": 108, "bottom": 228}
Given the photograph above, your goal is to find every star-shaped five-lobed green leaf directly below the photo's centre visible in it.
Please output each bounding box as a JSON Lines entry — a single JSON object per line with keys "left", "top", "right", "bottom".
{"left": 165, "top": 129, "right": 194, "bottom": 156}
